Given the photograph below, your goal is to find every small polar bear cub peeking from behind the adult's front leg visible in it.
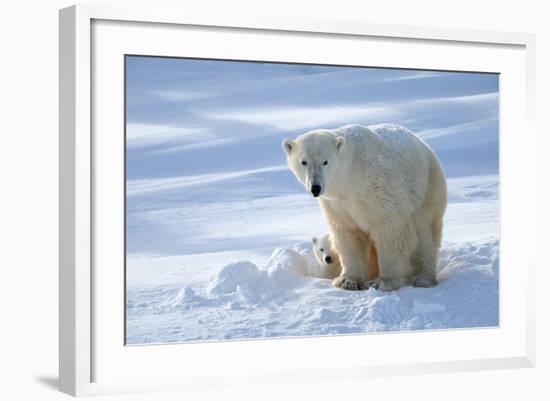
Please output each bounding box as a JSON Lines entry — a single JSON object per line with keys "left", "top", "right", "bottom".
{"left": 311, "top": 234, "right": 378, "bottom": 280}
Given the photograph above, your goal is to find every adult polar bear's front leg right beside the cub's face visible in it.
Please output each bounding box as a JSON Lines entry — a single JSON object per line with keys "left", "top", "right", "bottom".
{"left": 332, "top": 227, "right": 365, "bottom": 291}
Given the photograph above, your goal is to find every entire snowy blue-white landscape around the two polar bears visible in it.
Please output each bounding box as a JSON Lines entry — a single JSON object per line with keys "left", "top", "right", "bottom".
{"left": 126, "top": 56, "right": 499, "bottom": 344}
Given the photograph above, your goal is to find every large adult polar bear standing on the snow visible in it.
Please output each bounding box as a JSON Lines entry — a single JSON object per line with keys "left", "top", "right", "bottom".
{"left": 283, "top": 124, "right": 447, "bottom": 291}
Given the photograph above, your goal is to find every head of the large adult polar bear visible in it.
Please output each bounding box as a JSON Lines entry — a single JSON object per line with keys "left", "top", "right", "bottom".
{"left": 283, "top": 130, "right": 346, "bottom": 197}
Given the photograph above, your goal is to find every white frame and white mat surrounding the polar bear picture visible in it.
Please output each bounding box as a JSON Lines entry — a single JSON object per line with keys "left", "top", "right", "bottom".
{"left": 59, "top": 5, "right": 536, "bottom": 396}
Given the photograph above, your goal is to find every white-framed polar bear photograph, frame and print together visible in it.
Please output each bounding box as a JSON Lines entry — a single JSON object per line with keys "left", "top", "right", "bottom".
{"left": 60, "top": 6, "right": 535, "bottom": 395}
